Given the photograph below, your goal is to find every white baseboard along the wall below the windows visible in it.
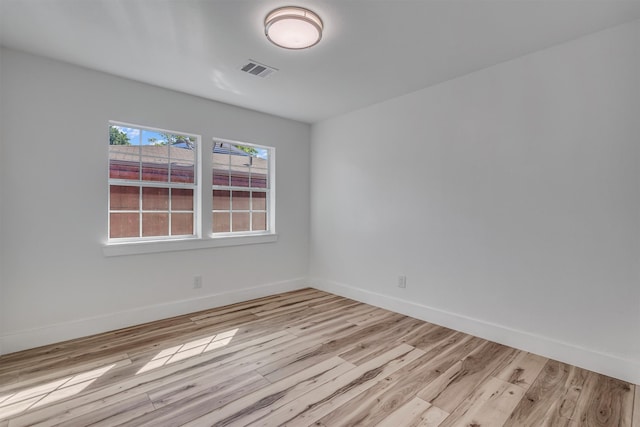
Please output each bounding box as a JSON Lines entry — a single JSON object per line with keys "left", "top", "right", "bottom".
{"left": 0, "top": 278, "right": 308, "bottom": 355}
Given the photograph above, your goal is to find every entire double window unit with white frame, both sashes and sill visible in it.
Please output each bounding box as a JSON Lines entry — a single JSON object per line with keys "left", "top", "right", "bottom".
{"left": 103, "top": 122, "right": 277, "bottom": 256}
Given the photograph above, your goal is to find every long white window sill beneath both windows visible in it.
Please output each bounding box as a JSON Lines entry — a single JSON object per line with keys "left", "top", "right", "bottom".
{"left": 102, "top": 234, "right": 278, "bottom": 257}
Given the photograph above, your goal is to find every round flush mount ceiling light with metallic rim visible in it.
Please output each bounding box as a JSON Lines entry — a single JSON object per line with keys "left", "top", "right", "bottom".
{"left": 264, "top": 6, "right": 323, "bottom": 49}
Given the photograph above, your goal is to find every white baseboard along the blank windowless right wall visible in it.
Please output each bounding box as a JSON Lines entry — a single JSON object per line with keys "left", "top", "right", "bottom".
{"left": 309, "top": 278, "right": 640, "bottom": 384}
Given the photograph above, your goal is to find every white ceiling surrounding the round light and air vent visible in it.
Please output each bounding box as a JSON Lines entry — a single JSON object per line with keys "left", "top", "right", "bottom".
{"left": 0, "top": 0, "right": 640, "bottom": 123}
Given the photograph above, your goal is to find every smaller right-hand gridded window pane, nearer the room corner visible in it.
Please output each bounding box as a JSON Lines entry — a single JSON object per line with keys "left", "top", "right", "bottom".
{"left": 212, "top": 140, "right": 273, "bottom": 235}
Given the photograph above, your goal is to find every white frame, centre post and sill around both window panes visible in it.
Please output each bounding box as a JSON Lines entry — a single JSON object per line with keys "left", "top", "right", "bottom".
{"left": 102, "top": 120, "right": 278, "bottom": 257}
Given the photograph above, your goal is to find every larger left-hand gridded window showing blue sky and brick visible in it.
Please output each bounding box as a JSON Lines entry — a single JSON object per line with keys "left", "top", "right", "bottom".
{"left": 109, "top": 123, "right": 198, "bottom": 240}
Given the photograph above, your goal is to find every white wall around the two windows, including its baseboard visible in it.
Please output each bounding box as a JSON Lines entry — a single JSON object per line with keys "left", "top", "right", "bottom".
{"left": 0, "top": 49, "right": 310, "bottom": 352}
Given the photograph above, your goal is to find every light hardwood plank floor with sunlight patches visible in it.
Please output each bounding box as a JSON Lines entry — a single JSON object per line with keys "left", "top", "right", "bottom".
{"left": 0, "top": 289, "right": 640, "bottom": 427}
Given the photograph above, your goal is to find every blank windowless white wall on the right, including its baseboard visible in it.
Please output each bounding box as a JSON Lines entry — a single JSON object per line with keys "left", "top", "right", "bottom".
{"left": 310, "top": 21, "right": 640, "bottom": 383}
